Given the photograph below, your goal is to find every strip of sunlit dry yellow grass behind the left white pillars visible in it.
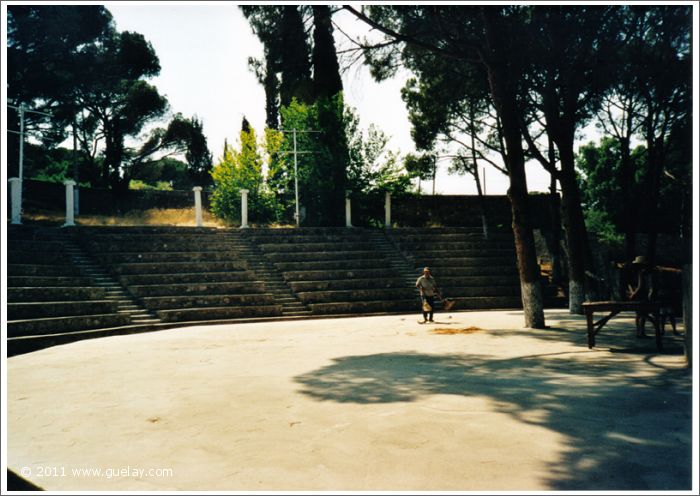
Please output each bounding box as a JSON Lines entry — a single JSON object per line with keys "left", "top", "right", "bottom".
{"left": 23, "top": 207, "right": 227, "bottom": 228}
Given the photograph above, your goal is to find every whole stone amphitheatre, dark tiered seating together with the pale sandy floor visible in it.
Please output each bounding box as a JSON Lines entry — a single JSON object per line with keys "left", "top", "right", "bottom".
{"left": 6, "top": 203, "right": 692, "bottom": 491}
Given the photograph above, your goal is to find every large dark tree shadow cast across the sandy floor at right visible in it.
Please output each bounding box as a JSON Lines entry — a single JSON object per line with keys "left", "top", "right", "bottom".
{"left": 295, "top": 331, "right": 692, "bottom": 490}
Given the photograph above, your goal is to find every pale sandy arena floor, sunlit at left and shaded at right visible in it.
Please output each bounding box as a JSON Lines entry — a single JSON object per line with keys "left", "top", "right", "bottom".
{"left": 7, "top": 310, "right": 697, "bottom": 492}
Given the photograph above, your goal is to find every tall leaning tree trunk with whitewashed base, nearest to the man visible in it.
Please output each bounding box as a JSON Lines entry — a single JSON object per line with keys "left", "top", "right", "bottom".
{"left": 481, "top": 7, "right": 545, "bottom": 329}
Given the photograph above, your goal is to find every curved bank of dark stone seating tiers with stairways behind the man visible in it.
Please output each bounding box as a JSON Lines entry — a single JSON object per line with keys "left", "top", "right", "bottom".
{"left": 7, "top": 226, "right": 564, "bottom": 354}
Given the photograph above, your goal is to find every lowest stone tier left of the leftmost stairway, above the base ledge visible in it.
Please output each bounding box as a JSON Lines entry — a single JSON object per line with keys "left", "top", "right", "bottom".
{"left": 7, "top": 313, "right": 131, "bottom": 338}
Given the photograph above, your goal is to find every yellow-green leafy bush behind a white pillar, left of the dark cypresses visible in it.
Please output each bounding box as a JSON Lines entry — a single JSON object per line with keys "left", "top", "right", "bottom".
{"left": 211, "top": 127, "right": 280, "bottom": 224}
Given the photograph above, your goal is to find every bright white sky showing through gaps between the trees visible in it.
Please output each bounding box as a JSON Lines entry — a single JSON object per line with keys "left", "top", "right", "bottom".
{"left": 105, "top": 2, "right": 549, "bottom": 194}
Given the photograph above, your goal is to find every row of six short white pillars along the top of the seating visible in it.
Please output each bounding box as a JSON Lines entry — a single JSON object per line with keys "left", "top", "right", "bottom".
{"left": 9, "top": 177, "right": 391, "bottom": 229}
